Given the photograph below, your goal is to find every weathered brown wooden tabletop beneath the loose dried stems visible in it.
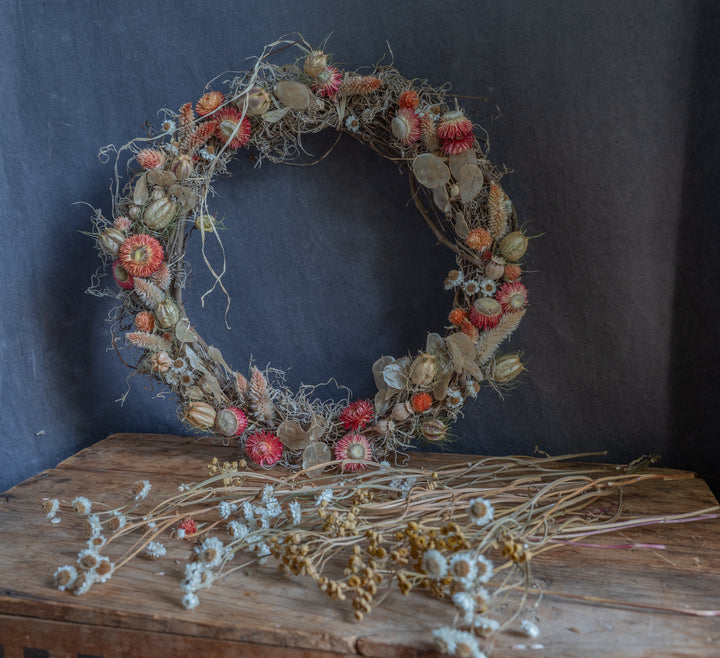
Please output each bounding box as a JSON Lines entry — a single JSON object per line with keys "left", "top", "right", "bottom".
{"left": 0, "top": 434, "right": 720, "bottom": 658}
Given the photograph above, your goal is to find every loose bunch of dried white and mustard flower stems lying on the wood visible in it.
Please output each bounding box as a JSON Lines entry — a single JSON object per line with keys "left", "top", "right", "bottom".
{"left": 49, "top": 455, "right": 720, "bottom": 656}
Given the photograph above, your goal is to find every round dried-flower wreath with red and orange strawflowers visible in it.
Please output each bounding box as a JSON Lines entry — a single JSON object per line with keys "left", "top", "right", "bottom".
{"left": 90, "top": 40, "right": 528, "bottom": 471}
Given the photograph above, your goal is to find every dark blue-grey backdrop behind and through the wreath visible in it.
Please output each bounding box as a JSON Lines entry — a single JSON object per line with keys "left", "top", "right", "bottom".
{"left": 0, "top": 0, "right": 720, "bottom": 490}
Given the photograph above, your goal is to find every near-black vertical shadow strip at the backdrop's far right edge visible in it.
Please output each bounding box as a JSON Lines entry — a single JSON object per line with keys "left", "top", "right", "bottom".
{"left": 663, "top": 3, "right": 720, "bottom": 496}
